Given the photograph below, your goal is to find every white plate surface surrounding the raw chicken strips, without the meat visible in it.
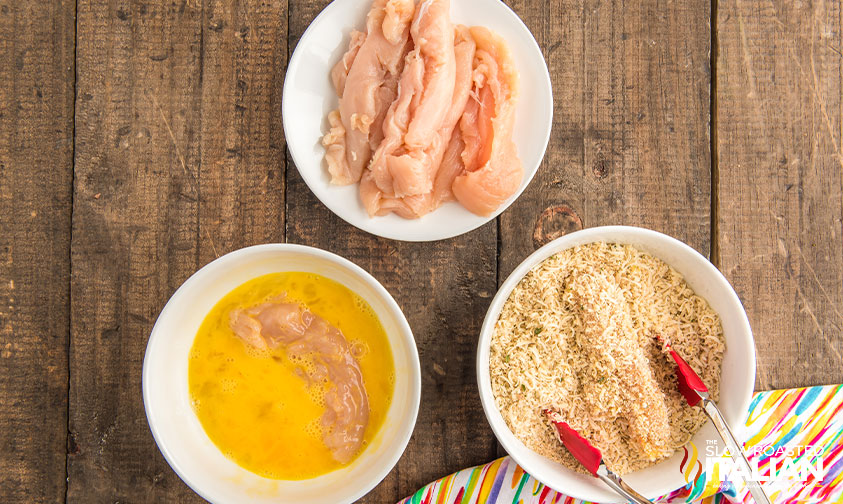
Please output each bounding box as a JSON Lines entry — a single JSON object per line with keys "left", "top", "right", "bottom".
{"left": 281, "top": 0, "right": 553, "bottom": 241}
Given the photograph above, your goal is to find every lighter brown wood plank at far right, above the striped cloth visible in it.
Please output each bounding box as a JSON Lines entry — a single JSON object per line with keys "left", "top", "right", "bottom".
{"left": 716, "top": 0, "right": 843, "bottom": 389}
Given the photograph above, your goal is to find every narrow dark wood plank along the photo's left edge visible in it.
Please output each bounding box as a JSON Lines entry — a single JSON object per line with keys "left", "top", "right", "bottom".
{"left": 0, "top": 0, "right": 75, "bottom": 502}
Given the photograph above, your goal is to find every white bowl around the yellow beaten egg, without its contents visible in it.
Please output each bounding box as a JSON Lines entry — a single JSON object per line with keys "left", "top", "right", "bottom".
{"left": 143, "top": 244, "right": 421, "bottom": 504}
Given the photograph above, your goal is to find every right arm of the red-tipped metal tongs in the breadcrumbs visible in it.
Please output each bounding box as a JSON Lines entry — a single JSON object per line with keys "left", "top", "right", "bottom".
{"left": 656, "top": 336, "right": 771, "bottom": 504}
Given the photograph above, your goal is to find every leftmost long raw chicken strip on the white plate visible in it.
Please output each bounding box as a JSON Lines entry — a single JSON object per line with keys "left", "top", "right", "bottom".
{"left": 322, "top": 0, "right": 414, "bottom": 185}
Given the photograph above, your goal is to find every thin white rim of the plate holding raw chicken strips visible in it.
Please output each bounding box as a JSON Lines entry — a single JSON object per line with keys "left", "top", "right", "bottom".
{"left": 281, "top": 0, "right": 554, "bottom": 242}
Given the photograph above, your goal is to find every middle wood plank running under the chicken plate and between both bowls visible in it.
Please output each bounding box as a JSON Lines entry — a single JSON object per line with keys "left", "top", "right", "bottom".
{"left": 287, "top": 0, "right": 497, "bottom": 503}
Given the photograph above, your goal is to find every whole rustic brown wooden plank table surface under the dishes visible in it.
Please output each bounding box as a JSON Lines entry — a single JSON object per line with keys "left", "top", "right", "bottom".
{"left": 0, "top": 0, "right": 843, "bottom": 503}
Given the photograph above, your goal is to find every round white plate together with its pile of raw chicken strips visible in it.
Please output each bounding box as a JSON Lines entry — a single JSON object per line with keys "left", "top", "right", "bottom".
{"left": 282, "top": 0, "right": 553, "bottom": 241}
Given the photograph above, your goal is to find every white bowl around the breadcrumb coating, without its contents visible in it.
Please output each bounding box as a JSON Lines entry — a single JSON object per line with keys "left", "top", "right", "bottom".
{"left": 477, "top": 226, "right": 755, "bottom": 502}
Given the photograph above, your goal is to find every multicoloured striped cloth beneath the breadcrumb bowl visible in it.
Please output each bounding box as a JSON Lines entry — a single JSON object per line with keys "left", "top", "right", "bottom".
{"left": 399, "top": 385, "right": 843, "bottom": 504}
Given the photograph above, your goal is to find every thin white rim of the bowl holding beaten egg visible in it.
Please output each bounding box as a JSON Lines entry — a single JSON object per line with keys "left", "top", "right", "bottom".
{"left": 141, "top": 243, "right": 421, "bottom": 502}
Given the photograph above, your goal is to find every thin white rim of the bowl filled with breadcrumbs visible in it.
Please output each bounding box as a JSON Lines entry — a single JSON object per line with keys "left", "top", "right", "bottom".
{"left": 476, "top": 226, "right": 756, "bottom": 502}
